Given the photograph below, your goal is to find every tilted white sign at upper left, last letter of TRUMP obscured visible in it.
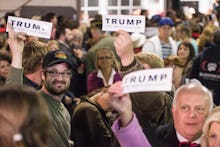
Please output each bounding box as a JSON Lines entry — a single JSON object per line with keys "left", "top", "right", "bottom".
{"left": 6, "top": 16, "right": 52, "bottom": 39}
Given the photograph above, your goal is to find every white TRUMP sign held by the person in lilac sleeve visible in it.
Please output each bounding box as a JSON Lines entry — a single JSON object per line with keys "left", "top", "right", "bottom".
{"left": 122, "top": 67, "right": 173, "bottom": 93}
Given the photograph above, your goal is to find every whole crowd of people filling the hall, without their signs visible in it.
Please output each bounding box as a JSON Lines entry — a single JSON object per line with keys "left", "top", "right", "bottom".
{"left": 0, "top": 4, "right": 220, "bottom": 147}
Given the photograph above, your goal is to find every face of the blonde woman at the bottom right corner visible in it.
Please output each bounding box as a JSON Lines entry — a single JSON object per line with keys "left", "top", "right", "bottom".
{"left": 208, "top": 122, "right": 220, "bottom": 147}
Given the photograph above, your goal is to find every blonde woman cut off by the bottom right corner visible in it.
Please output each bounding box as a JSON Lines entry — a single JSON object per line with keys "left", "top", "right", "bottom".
{"left": 201, "top": 106, "right": 220, "bottom": 147}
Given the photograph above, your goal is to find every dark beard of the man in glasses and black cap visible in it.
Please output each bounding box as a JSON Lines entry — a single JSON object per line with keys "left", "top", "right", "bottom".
{"left": 45, "top": 81, "right": 69, "bottom": 95}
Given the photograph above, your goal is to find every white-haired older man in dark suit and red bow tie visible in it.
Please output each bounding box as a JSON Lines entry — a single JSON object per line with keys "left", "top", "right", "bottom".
{"left": 157, "top": 83, "right": 213, "bottom": 147}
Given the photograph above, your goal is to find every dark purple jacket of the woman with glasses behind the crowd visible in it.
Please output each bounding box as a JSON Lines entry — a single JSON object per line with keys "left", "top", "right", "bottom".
{"left": 87, "top": 72, "right": 122, "bottom": 93}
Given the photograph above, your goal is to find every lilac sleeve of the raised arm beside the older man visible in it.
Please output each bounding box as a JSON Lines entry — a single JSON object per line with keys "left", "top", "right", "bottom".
{"left": 112, "top": 114, "right": 151, "bottom": 147}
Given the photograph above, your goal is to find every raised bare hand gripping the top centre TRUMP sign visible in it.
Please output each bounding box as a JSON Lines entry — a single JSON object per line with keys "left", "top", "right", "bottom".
{"left": 114, "top": 30, "right": 134, "bottom": 66}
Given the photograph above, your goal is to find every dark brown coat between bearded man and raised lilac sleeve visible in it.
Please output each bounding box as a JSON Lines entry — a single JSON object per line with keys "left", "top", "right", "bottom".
{"left": 71, "top": 99, "right": 119, "bottom": 147}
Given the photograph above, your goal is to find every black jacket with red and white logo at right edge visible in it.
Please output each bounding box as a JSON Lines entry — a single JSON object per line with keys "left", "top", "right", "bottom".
{"left": 190, "top": 44, "right": 220, "bottom": 105}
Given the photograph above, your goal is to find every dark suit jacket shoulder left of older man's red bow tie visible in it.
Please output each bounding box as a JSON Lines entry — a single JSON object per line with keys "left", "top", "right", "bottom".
{"left": 156, "top": 123, "right": 179, "bottom": 147}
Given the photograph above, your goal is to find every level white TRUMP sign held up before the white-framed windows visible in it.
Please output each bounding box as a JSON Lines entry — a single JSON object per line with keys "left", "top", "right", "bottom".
{"left": 102, "top": 15, "right": 145, "bottom": 33}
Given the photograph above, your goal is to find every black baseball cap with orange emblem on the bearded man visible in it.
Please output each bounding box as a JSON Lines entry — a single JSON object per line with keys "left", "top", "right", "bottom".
{"left": 42, "top": 50, "right": 73, "bottom": 68}
